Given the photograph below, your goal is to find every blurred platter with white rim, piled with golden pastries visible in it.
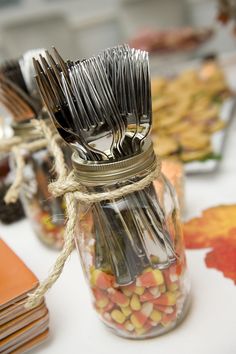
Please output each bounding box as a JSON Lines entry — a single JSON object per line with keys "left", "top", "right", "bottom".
{"left": 152, "top": 53, "right": 236, "bottom": 174}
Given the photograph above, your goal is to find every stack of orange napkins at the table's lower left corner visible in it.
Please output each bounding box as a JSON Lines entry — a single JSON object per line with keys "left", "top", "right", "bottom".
{"left": 0, "top": 239, "right": 49, "bottom": 354}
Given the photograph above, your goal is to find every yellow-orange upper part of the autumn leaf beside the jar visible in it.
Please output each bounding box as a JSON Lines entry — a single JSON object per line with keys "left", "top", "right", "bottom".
{"left": 183, "top": 204, "right": 236, "bottom": 249}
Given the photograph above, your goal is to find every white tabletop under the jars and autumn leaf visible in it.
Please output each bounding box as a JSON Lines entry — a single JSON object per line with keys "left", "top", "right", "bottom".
{"left": 0, "top": 67, "right": 236, "bottom": 354}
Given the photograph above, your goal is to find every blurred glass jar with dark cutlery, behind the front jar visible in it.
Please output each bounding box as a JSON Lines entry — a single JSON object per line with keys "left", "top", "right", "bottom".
{"left": 13, "top": 122, "right": 65, "bottom": 249}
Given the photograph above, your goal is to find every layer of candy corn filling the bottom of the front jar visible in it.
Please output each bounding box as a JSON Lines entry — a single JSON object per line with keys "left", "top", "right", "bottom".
{"left": 91, "top": 264, "right": 185, "bottom": 336}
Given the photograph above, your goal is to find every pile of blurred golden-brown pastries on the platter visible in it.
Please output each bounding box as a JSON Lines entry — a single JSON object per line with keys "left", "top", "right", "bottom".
{"left": 152, "top": 60, "right": 232, "bottom": 162}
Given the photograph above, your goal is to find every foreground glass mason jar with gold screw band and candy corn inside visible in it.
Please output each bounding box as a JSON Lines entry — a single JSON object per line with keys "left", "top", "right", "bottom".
{"left": 72, "top": 141, "right": 190, "bottom": 339}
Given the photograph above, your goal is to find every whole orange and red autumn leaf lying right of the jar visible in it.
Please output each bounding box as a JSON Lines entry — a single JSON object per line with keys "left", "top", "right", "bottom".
{"left": 184, "top": 205, "right": 236, "bottom": 284}
